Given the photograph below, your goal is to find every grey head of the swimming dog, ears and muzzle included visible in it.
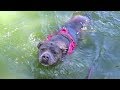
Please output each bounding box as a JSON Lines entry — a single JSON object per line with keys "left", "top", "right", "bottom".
{"left": 37, "top": 42, "right": 66, "bottom": 66}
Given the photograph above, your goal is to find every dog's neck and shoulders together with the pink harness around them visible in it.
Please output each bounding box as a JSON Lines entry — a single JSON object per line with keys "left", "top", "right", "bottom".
{"left": 47, "top": 27, "right": 76, "bottom": 54}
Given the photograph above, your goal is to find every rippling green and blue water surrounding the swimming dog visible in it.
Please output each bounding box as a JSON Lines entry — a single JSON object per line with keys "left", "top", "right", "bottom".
{"left": 0, "top": 11, "right": 120, "bottom": 79}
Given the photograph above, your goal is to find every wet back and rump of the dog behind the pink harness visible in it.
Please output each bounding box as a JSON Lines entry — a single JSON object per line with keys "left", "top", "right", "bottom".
{"left": 64, "top": 15, "right": 90, "bottom": 42}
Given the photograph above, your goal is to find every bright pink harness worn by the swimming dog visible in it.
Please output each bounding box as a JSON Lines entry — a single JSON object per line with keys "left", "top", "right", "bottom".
{"left": 47, "top": 27, "right": 76, "bottom": 55}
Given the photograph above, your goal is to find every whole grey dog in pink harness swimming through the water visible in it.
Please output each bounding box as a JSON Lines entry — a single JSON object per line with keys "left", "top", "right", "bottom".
{"left": 37, "top": 15, "right": 89, "bottom": 66}
